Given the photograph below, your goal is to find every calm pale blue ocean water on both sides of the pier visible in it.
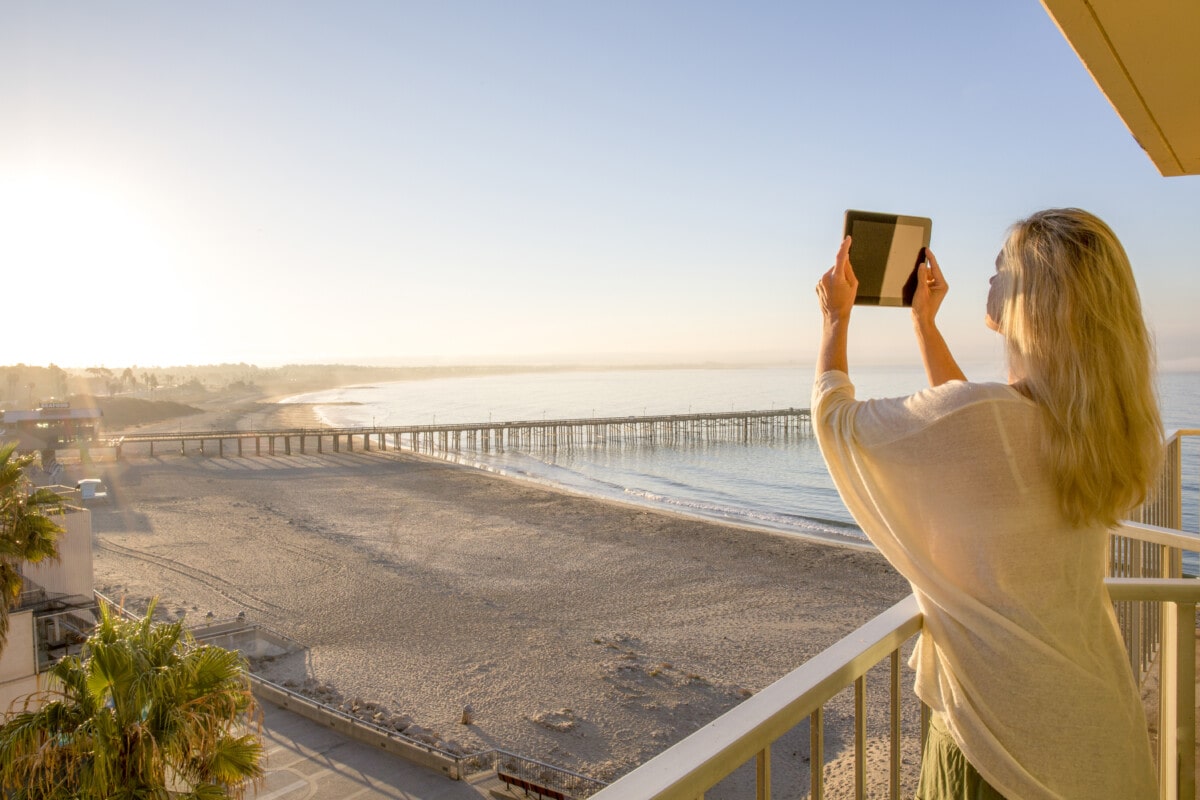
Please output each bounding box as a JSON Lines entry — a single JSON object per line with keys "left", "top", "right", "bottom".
{"left": 289, "top": 367, "right": 1200, "bottom": 551}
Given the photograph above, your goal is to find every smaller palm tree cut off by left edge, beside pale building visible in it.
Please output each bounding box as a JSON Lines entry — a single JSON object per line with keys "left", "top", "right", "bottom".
{"left": 0, "top": 443, "right": 62, "bottom": 650}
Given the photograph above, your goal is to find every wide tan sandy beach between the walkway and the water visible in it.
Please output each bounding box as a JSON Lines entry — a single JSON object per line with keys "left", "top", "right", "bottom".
{"left": 75, "top": 407, "right": 916, "bottom": 798}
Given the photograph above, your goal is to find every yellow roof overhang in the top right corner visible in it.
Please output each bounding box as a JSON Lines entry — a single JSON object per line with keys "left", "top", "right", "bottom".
{"left": 1042, "top": 0, "right": 1200, "bottom": 176}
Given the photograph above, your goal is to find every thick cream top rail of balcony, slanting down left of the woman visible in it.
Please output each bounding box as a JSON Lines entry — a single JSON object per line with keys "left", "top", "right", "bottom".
{"left": 593, "top": 595, "right": 922, "bottom": 800}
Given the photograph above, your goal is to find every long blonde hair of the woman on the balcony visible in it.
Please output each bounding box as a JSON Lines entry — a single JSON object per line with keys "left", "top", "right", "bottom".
{"left": 998, "top": 209, "right": 1163, "bottom": 527}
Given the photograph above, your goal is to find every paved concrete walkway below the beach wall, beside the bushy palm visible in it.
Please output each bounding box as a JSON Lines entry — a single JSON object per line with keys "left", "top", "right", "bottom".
{"left": 258, "top": 703, "right": 491, "bottom": 800}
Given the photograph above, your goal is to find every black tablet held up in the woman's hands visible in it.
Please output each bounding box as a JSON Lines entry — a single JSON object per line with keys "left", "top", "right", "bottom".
{"left": 842, "top": 210, "right": 934, "bottom": 306}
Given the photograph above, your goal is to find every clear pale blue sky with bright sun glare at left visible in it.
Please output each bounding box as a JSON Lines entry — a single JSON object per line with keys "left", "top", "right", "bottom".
{"left": 0, "top": 0, "right": 1200, "bottom": 374}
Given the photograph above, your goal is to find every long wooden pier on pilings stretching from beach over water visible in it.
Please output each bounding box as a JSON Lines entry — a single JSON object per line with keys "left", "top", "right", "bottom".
{"left": 108, "top": 408, "right": 812, "bottom": 458}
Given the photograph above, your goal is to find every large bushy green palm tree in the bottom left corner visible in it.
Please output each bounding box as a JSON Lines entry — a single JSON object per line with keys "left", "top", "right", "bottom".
{"left": 0, "top": 603, "right": 263, "bottom": 800}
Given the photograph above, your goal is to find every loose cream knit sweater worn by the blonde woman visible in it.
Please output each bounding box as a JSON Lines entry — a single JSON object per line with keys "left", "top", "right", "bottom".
{"left": 812, "top": 371, "right": 1158, "bottom": 800}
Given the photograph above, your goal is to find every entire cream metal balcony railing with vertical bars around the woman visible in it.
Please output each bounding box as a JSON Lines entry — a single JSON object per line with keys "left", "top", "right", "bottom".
{"left": 592, "top": 431, "right": 1200, "bottom": 800}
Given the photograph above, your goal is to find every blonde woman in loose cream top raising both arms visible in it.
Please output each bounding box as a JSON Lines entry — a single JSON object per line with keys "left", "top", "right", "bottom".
{"left": 812, "top": 209, "right": 1163, "bottom": 800}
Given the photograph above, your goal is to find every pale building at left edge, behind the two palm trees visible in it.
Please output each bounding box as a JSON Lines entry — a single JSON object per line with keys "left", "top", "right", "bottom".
{"left": 0, "top": 496, "right": 97, "bottom": 718}
